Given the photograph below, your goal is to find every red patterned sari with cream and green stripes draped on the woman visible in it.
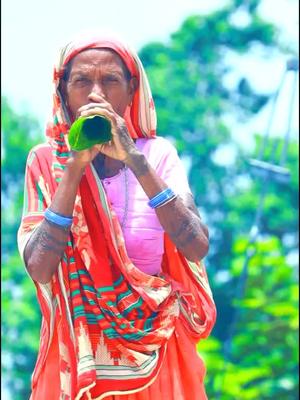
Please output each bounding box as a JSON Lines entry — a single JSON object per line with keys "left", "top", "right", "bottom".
{"left": 18, "top": 35, "right": 216, "bottom": 400}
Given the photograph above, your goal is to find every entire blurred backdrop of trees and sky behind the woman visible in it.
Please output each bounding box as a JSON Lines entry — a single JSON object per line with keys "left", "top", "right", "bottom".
{"left": 1, "top": 0, "right": 299, "bottom": 400}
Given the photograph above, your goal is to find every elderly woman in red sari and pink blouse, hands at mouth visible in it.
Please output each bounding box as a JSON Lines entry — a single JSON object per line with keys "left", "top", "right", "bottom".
{"left": 18, "top": 37, "right": 215, "bottom": 400}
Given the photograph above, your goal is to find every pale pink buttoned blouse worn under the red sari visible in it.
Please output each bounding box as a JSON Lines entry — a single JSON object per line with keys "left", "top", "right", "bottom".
{"left": 102, "top": 137, "right": 191, "bottom": 275}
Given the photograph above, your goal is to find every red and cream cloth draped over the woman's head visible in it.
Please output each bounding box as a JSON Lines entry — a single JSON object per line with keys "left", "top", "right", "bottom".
{"left": 47, "top": 35, "right": 156, "bottom": 141}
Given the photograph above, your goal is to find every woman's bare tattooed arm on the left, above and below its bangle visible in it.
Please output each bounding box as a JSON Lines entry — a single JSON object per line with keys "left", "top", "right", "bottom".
{"left": 24, "top": 159, "right": 84, "bottom": 283}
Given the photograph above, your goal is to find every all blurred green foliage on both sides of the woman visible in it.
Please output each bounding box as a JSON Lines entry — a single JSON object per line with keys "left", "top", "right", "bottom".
{"left": 1, "top": 0, "right": 299, "bottom": 400}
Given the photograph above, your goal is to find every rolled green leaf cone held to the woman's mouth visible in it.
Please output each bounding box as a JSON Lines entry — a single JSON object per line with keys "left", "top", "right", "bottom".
{"left": 68, "top": 115, "right": 112, "bottom": 151}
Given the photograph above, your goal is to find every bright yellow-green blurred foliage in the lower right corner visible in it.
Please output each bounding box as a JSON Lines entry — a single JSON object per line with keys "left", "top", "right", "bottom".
{"left": 198, "top": 236, "right": 299, "bottom": 400}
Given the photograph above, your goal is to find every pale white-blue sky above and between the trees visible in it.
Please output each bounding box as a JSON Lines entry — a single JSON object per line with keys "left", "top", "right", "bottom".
{"left": 1, "top": 0, "right": 299, "bottom": 150}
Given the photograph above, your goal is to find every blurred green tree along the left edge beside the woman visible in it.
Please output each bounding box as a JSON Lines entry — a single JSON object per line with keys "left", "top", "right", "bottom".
{"left": 1, "top": 97, "right": 42, "bottom": 400}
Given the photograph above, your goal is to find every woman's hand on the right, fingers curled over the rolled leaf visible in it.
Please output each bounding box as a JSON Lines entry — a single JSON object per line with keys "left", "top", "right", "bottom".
{"left": 77, "top": 93, "right": 137, "bottom": 162}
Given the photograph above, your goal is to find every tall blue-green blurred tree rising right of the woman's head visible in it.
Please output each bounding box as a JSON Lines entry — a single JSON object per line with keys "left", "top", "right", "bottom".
{"left": 140, "top": 0, "right": 298, "bottom": 339}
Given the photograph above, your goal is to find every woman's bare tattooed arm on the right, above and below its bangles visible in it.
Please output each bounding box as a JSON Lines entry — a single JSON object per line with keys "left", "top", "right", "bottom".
{"left": 125, "top": 152, "right": 209, "bottom": 261}
